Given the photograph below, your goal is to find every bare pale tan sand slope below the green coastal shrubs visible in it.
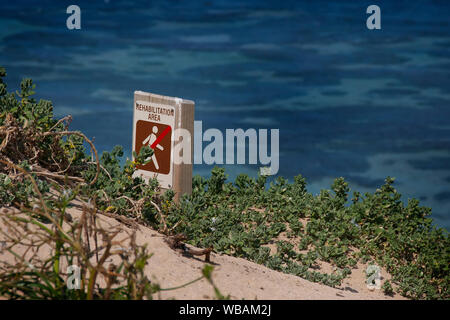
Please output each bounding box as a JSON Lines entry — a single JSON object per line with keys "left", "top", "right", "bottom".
{"left": 0, "top": 208, "right": 402, "bottom": 300}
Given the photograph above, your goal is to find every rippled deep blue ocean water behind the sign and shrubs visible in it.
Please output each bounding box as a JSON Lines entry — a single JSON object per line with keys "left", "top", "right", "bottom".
{"left": 0, "top": 0, "right": 450, "bottom": 229}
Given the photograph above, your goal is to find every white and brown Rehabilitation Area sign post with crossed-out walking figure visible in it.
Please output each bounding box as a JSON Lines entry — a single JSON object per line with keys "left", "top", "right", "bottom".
{"left": 133, "top": 91, "right": 195, "bottom": 200}
